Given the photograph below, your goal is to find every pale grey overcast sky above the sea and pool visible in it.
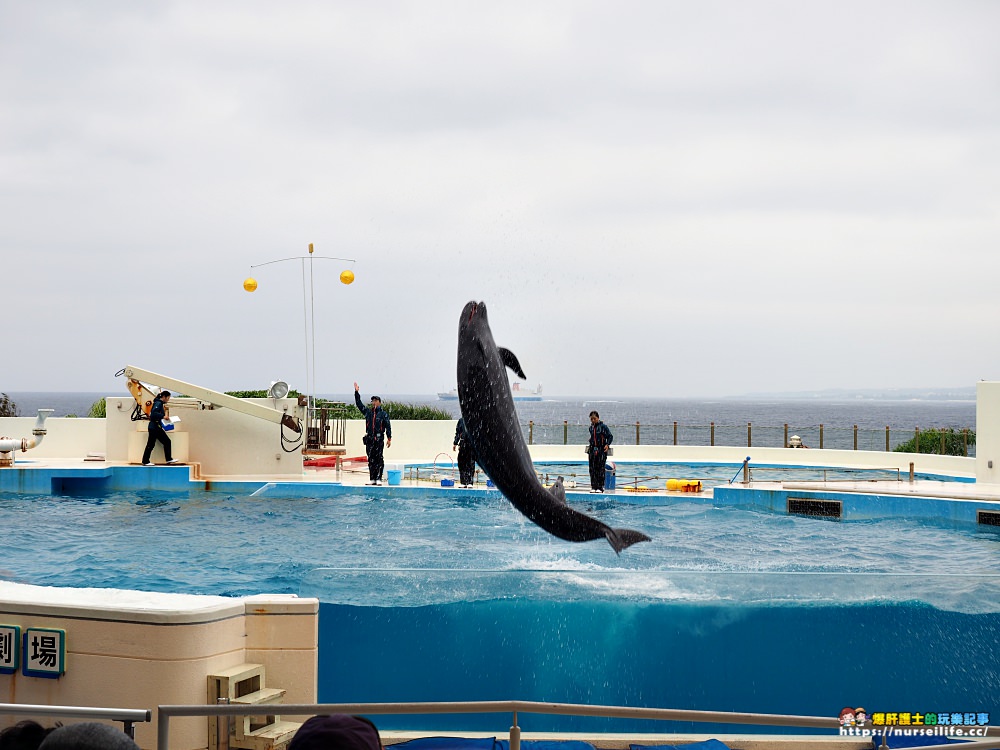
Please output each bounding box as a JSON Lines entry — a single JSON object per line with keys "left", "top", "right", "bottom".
{"left": 0, "top": 0, "right": 1000, "bottom": 397}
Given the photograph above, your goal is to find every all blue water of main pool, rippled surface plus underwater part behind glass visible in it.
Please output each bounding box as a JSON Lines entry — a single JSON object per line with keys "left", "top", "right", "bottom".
{"left": 0, "top": 488, "right": 1000, "bottom": 731}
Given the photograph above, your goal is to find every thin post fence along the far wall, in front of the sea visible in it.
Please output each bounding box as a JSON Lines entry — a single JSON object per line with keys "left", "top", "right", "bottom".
{"left": 521, "top": 420, "right": 975, "bottom": 456}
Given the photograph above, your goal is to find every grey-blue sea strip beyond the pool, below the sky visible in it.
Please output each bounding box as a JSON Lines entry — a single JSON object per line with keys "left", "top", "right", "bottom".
{"left": 8, "top": 391, "right": 976, "bottom": 455}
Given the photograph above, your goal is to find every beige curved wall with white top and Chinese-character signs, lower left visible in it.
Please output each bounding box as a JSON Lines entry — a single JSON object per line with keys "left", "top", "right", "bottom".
{"left": 0, "top": 581, "right": 319, "bottom": 750}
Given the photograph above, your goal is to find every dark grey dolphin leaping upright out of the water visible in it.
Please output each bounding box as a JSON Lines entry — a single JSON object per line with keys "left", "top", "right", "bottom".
{"left": 458, "top": 302, "right": 650, "bottom": 554}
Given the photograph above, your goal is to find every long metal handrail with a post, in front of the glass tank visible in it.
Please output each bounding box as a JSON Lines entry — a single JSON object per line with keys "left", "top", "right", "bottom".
{"left": 156, "top": 700, "right": 840, "bottom": 750}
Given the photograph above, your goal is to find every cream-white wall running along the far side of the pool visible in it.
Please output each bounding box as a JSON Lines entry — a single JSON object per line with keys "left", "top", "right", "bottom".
{"left": 0, "top": 382, "right": 1000, "bottom": 484}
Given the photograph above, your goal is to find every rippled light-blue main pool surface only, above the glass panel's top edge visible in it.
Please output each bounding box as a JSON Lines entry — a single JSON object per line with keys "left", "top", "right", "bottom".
{"left": 0, "top": 488, "right": 1000, "bottom": 592}
